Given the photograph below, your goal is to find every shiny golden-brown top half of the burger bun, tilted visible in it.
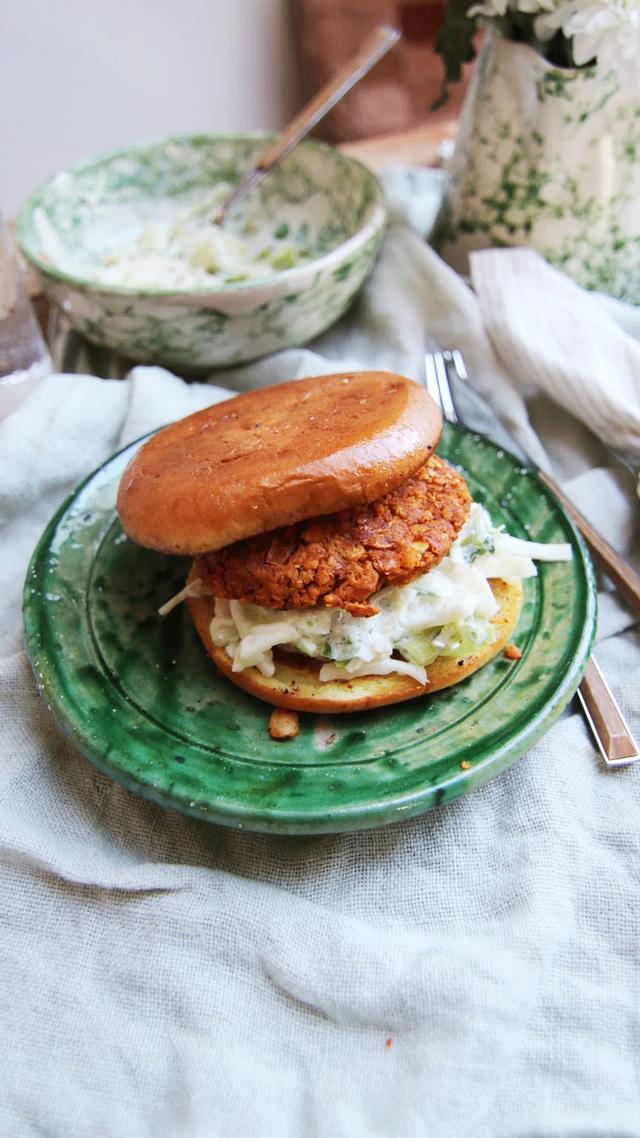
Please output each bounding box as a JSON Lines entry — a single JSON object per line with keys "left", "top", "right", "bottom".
{"left": 117, "top": 371, "right": 442, "bottom": 554}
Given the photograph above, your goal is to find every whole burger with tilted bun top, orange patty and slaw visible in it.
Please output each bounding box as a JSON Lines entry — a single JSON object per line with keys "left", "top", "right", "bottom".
{"left": 117, "top": 372, "right": 571, "bottom": 712}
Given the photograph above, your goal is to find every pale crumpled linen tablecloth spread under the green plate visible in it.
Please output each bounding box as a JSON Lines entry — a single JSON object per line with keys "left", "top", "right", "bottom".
{"left": 0, "top": 170, "right": 640, "bottom": 1138}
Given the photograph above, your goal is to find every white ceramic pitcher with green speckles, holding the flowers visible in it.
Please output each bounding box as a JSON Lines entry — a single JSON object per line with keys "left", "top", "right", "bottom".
{"left": 434, "top": 35, "right": 640, "bottom": 303}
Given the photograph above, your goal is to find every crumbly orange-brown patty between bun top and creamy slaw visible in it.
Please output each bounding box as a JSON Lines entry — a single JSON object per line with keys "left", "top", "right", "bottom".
{"left": 196, "top": 455, "right": 471, "bottom": 617}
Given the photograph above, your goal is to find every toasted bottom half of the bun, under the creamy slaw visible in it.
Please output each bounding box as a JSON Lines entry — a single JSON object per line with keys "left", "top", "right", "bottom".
{"left": 187, "top": 580, "right": 523, "bottom": 715}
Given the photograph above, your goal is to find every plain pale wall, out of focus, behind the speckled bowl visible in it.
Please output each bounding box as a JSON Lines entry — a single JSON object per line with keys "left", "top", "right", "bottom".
{"left": 0, "top": 0, "right": 301, "bottom": 216}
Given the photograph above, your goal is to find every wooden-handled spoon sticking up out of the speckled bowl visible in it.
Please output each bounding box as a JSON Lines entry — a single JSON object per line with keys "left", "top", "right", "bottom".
{"left": 215, "top": 24, "right": 401, "bottom": 224}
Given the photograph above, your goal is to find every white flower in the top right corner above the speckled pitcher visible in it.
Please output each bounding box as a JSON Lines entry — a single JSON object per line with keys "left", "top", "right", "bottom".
{"left": 535, "top": 0, "right": 640, "bottom": 86}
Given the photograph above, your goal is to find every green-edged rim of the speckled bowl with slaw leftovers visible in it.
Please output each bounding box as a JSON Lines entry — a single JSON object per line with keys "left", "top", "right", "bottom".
{"left": 15, "top": 131, "right": 387, "bottom": 304}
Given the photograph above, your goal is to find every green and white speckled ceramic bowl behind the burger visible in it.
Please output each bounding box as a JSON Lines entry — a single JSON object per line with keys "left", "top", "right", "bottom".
{"left": 17, "top": 135, "right": 386, "bottom": 372}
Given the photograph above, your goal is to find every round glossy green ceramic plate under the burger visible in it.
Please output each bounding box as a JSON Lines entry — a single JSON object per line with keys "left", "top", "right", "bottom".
{"left": 24, "top": 427, "right": 596, "bottom": 833}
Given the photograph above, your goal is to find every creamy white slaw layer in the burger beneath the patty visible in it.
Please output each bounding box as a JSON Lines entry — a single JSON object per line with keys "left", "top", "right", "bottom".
{"left": 171, "top": 503, "right": 572, "bottom": 684}
